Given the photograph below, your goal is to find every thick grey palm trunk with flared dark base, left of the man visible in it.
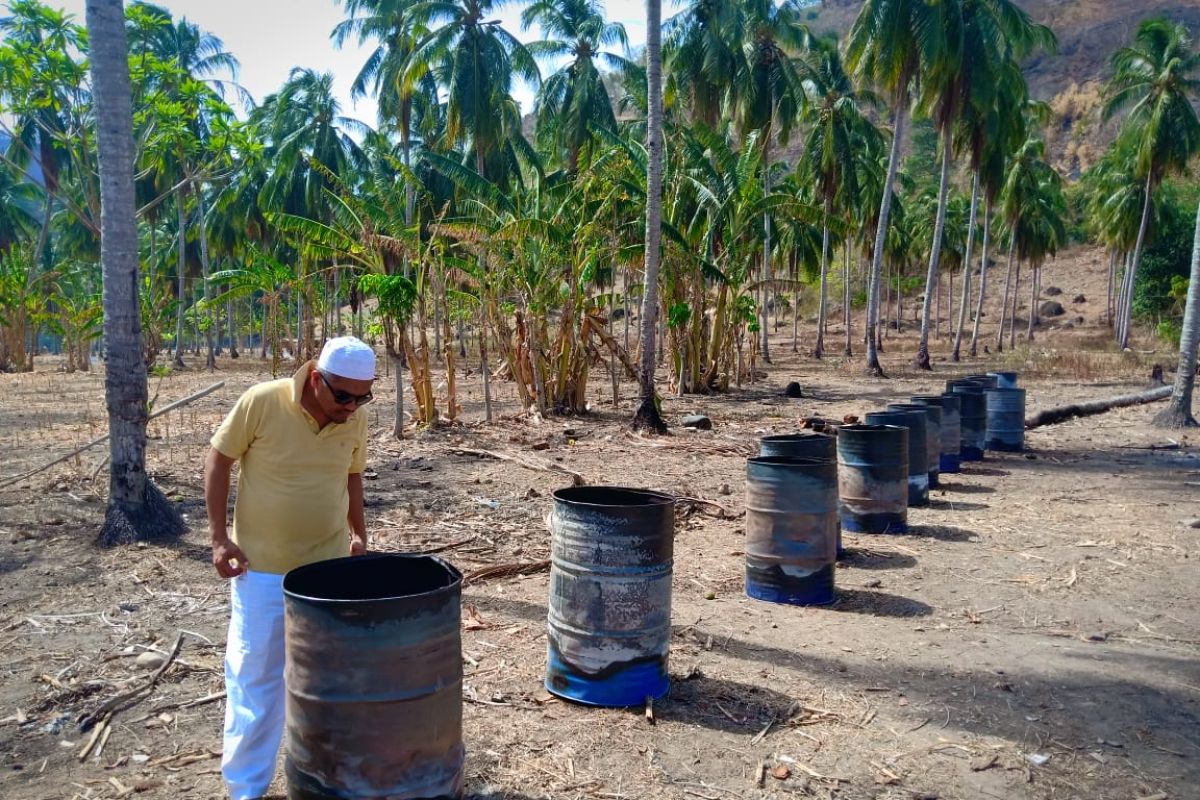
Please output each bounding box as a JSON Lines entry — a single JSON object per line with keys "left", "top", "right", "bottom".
{"left": 86, "top": 0, "right": 186, "bottom": 545}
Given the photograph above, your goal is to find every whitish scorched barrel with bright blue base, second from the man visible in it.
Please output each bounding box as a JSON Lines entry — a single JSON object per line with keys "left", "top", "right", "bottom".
{"left": 546, "top": 486, "right": 674, "bottom": 706}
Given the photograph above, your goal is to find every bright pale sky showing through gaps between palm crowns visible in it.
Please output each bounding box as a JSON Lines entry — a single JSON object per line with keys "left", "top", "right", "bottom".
{"left": 37, "top": 0, "right": 683, "bottom": 125}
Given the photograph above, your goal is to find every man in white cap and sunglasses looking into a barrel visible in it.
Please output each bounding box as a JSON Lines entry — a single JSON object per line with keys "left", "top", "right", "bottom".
{"left": 204, "top": 336, "right": 374, "bottom": 800}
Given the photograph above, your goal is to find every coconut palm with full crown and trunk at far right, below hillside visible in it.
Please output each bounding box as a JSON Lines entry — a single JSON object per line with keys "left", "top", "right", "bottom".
{"left": 1103, "top": 19, "right": 1200, "bottom": 349}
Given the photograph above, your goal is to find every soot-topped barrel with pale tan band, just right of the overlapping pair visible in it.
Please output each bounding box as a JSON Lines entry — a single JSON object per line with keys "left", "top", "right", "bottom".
{"left": 838, "top": 425, "right": 908, "bottom": 534}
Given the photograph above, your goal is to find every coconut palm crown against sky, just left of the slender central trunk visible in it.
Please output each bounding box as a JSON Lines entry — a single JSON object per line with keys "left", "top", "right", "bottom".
{"left": 521, "top": 0, "right": 629, "bottom": 174}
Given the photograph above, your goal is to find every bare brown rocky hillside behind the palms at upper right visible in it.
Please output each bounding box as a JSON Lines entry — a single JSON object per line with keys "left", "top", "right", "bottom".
{"left": 809, "top": 0, "right": 1200, "bottom": 176}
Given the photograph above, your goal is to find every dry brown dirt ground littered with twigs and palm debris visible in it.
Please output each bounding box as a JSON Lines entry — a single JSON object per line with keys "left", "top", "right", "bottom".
{"left": 0, "top": 245, "right": 1200, "bottom": 800}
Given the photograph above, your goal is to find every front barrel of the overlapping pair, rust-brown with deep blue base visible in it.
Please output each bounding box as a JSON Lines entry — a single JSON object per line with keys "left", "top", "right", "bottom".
{"left": 745, "top": 456, "right": 838, "bottom": 606}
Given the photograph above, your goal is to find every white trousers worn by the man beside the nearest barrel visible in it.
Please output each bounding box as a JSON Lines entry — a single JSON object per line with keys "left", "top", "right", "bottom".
{"left": 221, "top": 572, "right": 287, "bottom": 800}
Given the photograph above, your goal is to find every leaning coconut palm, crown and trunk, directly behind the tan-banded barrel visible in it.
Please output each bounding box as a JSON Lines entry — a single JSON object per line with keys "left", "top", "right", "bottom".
{"left": 846, "top": 0, "right": 949, "bottom": 377}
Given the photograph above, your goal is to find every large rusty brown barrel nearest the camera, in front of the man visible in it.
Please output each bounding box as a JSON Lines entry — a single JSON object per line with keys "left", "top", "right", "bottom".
{"left": 283, "top": 553, "right": 464, "bottom": 800}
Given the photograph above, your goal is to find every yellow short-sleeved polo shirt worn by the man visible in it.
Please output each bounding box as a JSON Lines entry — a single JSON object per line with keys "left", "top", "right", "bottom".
{"left": 211, "top": 361, "right": 367, "bottom": 575}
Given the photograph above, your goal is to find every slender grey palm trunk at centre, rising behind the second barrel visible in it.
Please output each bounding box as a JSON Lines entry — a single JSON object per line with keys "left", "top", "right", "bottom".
{"left": 634, "top": 0, "right": 667, "bottom": 433}
